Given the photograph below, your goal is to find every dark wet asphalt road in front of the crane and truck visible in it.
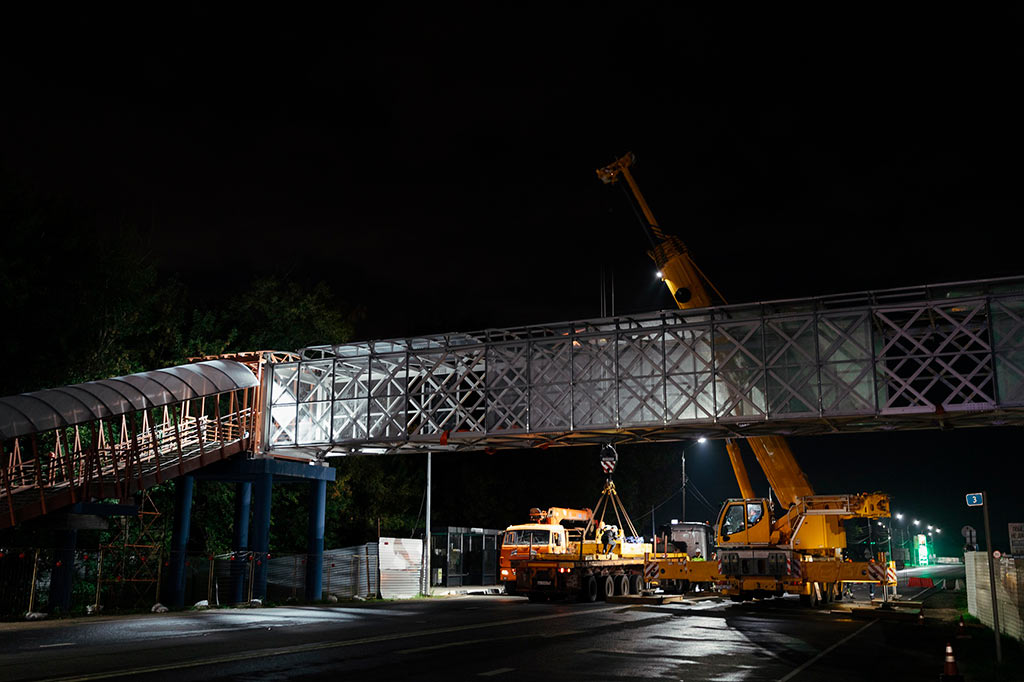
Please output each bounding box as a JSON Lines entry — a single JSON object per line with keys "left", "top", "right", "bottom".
{"left": 0, "top": 569, "right": 966, "bottom": 682}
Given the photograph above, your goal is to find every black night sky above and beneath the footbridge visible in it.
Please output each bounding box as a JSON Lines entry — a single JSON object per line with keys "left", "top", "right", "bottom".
{"left": 0, "top": 3, "right": 1024, "bottom": 550}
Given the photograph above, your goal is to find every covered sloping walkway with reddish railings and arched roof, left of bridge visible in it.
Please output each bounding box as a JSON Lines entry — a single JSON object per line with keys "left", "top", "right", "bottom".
{"left": 0, "top": 359, "right": 259, "bottom": 528}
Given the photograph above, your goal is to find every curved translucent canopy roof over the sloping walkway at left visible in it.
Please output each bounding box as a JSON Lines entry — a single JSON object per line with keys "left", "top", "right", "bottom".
{"left": 0, "top": 359, "right": 258, "bottom": 440}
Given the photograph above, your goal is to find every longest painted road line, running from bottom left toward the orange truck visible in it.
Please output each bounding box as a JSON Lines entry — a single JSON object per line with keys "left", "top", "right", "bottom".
{"left": 42, "top": 604, "right": 632, "bottom": 682}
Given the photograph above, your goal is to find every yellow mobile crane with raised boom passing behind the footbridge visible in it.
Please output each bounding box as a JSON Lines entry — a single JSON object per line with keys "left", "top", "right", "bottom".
{"left": 597, "top": 153, "right": 895, "bottom": 605}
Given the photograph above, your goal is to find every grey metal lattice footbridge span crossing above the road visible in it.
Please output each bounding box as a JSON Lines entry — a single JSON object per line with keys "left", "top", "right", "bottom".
{"left": 263, "top": 279, "right": 1024, "bottom": 453}
